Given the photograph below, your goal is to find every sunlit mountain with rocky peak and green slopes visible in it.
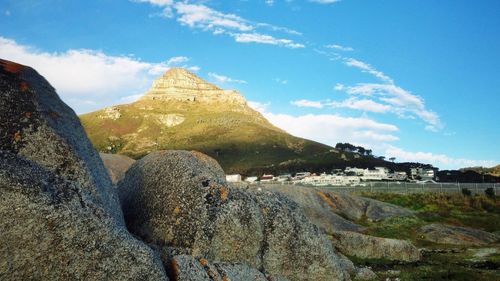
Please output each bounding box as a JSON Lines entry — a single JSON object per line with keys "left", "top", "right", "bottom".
{"left": 80, "top": 68, "right": 386, "bottom": 175}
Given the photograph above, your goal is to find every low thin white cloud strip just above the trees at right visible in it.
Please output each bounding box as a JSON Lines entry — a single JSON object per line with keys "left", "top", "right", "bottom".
{"left": 385, "top": 145, "right": 498, "bottom": 169}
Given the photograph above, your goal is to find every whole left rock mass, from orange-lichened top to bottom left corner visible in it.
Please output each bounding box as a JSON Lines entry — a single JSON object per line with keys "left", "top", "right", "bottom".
{"left": 0, "top": 61, "right": 167, "bottom": 280}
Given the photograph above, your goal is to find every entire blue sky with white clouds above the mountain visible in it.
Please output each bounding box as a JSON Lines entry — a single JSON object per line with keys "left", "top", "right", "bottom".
{"left": 0, "top": 0, "right": 500, "bottom": 169}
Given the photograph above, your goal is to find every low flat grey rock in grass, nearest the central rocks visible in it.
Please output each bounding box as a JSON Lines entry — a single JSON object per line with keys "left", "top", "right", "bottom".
{"left": 333, "top": 231, "right": 422, "bottom": 262}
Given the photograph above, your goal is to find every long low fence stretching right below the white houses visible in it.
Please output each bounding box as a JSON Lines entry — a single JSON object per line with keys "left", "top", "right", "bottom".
{"left": 264, "top": 182, "right": 500, "bottom": 195}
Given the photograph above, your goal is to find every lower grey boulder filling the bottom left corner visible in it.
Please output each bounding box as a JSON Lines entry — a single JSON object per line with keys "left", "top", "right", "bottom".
{"left": 0, "top": 151, "right": 168, "bottom": 280}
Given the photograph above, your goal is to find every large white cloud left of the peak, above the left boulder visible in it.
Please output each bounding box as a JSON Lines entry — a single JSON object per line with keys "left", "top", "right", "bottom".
{"left": 0, "top": 37, "right": 199, "bottom": 113}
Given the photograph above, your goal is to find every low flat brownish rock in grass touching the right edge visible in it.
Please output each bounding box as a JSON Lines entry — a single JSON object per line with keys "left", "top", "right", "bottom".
{"left": 419, "top": 223, "right": 499, "bottom": 246}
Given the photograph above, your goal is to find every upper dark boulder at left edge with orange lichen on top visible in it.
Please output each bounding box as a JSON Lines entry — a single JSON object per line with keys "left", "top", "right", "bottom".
{"left": 0, "top": 60, "right": 123, "bottom": 224}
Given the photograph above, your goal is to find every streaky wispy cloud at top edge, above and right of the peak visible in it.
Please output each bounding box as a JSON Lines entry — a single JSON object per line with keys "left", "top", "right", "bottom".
{"left": 133, "top": 0, "right": 305, "bottom": 49}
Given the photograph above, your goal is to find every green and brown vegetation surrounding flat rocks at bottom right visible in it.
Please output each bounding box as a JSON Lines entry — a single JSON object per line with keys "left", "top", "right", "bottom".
{"left": 353, "top": 193, "right": 500, "bottom": 281}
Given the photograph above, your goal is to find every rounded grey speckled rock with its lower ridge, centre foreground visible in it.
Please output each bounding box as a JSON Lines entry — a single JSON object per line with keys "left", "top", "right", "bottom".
{"left": 119, "top": 151, "right": 348, "bottom": 280}
